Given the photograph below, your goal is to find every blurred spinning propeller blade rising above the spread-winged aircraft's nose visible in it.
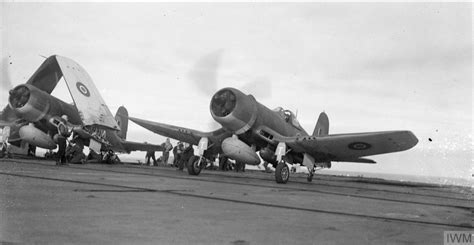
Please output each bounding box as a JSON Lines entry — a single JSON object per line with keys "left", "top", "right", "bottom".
{"left": 189, "top": 50, "right": 223, "bottom": 96}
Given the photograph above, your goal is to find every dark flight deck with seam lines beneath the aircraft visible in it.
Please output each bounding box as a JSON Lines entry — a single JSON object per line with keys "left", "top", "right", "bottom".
{"left": 0, "top": 159, "right": 474, "bottom": 244}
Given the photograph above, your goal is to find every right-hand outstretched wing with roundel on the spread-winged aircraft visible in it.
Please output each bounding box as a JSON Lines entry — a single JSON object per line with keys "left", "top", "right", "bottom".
{"left": 275, "top": 131, "right": 418, "bottom": 163}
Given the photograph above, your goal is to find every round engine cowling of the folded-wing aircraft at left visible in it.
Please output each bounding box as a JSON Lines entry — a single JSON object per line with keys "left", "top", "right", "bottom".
{"left": 8, "top": 84, "right": 51, "bottom": 122}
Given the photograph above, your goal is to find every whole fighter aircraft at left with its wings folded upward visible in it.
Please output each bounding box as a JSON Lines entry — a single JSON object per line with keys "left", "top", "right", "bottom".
{"left": 0, "top": 55, "right": 162, "bottom": 157}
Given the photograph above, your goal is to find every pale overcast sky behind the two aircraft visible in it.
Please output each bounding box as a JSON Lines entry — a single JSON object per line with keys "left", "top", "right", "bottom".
{"left": 0, "top": 3, "right": 473, "bottom": 184}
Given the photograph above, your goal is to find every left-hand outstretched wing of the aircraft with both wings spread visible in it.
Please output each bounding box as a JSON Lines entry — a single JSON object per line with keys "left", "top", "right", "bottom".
{"left": 129, "top": 117, "right": 232, "bottom": 145}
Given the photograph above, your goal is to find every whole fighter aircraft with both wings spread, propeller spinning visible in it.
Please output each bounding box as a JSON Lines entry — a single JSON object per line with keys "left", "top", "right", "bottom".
{"left": 129, "top": 88, "right": 418, "bottom": 183}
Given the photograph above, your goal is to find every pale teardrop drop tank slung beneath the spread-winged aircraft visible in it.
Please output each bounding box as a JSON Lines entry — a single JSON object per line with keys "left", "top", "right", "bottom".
{"left": 221, "top": 137, "right": 260, "bottom": 165}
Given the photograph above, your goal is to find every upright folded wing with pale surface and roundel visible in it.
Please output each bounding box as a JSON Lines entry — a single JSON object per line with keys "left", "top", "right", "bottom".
{"left": 55, "top": 56, "right": 119, "bottom": 130}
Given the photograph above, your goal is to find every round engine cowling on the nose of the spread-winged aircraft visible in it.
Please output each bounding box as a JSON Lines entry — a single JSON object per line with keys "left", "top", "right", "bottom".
{"left": 210, "top": 88, "right": 258, "bottom": 134}
